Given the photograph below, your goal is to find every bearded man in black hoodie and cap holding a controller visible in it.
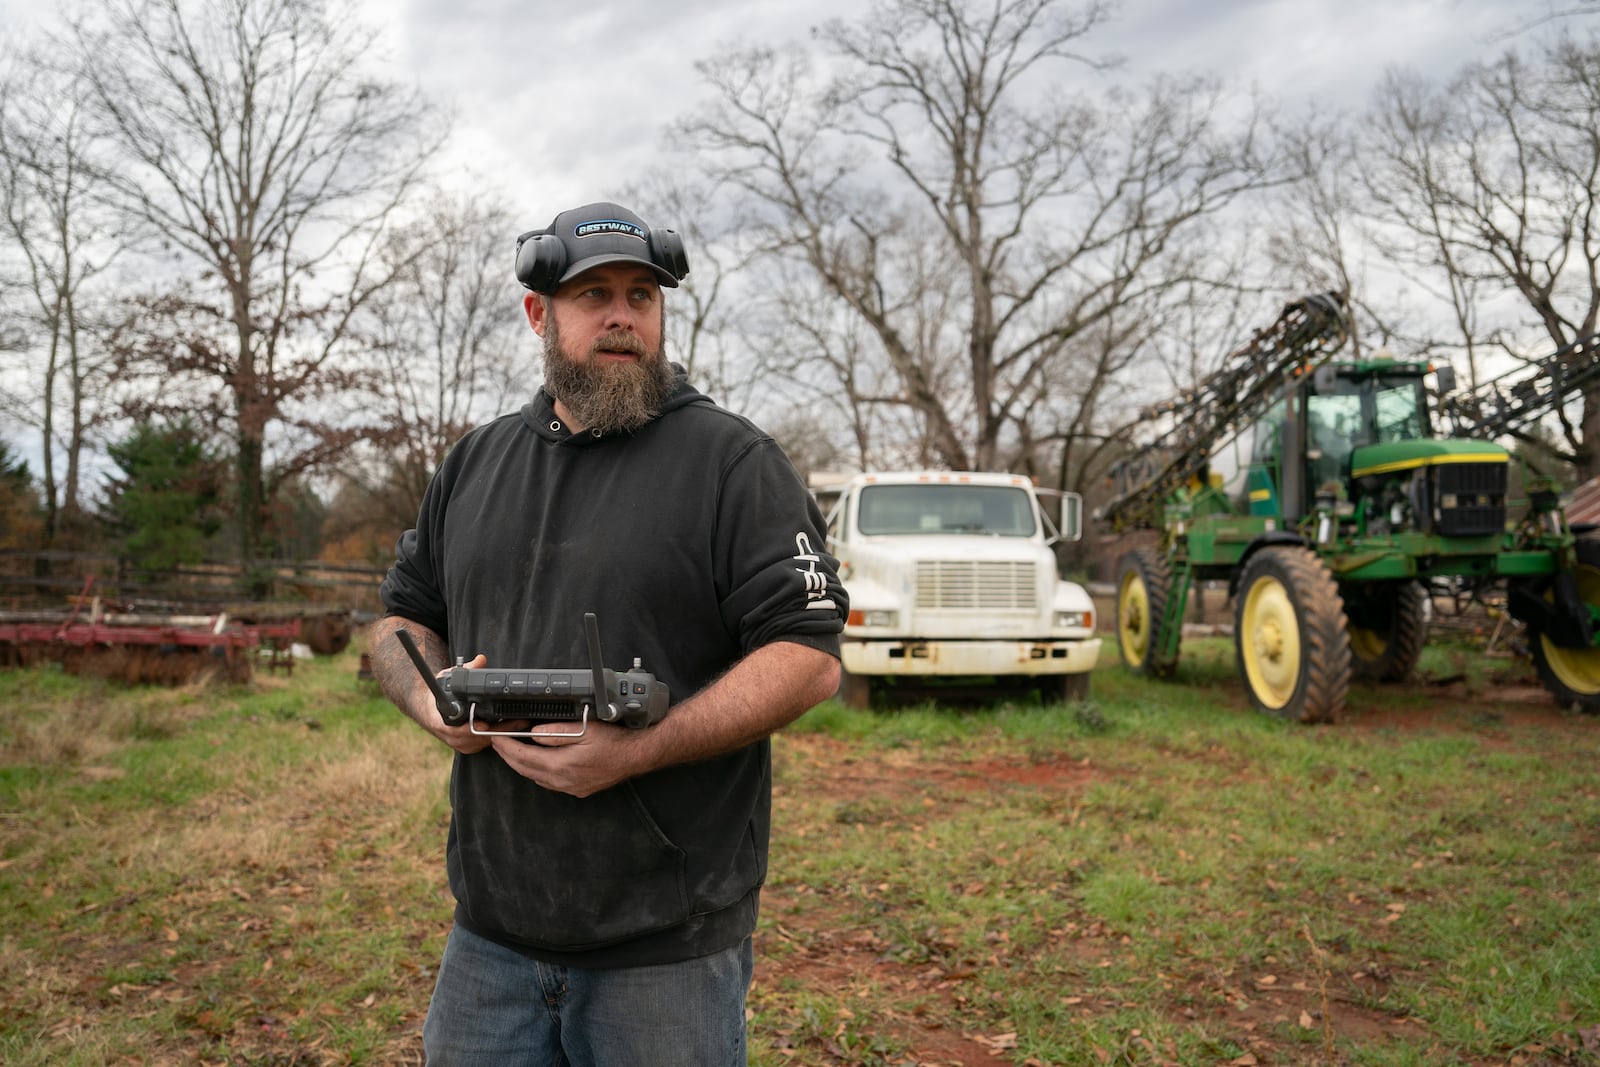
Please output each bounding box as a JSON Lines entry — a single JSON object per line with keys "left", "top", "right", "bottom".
{"left": 371, "top": 203, "right": 846, "bottom": 1067}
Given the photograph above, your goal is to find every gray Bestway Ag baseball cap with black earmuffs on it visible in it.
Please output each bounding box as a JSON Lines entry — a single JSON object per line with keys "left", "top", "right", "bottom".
{"left": 517, "top": 202, "right": 688, "bottom": 293}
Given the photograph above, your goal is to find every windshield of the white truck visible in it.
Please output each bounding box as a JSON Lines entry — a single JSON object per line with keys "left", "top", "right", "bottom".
{"left": 858, "top": 483, "right": 1034, "bottom": 537}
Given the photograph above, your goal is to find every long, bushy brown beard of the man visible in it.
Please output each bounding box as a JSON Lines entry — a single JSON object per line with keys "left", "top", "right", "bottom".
{"left": 544, "top": 315, "right": 672, "bottom": 434}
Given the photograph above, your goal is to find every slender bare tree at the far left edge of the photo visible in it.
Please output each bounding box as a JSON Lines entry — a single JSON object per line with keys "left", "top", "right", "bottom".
{"left": 0, "top": 51, "right": 126, "bottom": 547}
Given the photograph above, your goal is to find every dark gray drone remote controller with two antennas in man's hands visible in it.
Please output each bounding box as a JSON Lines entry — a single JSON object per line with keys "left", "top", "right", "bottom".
{"left": 395, "top": 611, "right": 670, "bottom": 737}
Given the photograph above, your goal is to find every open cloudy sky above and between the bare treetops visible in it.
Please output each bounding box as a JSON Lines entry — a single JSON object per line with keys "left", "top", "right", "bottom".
{"left": 0, "top": 0, "right": 1555, "bottom": 224}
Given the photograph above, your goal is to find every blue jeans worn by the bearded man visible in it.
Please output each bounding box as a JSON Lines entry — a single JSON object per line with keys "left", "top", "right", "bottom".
{"left": 422, "top": 926, "right": 755, "bottom": 1067}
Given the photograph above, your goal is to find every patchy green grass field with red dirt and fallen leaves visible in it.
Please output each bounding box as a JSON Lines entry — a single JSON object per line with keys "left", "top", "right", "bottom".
{"left": 0, "top": 640, "right": 1600, "bottom": 1067}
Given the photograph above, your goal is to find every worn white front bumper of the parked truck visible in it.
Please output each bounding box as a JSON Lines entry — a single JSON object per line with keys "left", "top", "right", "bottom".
{"left": 840, "top": 637, "right": 1101, "bottom": 675}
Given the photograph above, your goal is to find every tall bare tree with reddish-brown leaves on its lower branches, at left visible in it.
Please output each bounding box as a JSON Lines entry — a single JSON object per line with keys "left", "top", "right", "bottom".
{"left": 72, "top": 0, "right": 437, "bottom": 561}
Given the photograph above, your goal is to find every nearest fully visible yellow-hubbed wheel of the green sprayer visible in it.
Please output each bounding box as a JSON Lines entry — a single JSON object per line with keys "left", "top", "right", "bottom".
{"left": 1234, "top": 545, "right": 1350, "bottom": 723}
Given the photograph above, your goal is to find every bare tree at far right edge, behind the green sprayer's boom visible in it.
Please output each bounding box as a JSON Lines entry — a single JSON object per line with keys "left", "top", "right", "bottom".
{"left": 1376, "top": 37, "right": 1600, "bottom": 478}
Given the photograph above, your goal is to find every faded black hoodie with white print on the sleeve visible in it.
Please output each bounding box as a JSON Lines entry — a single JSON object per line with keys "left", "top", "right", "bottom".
{"left": 382, "top": 368, "right": 846, "bottom": 966}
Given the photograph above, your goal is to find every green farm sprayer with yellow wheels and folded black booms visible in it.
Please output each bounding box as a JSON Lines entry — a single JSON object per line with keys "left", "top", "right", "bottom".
{"left": 1099, "top": 293, "right": 1600, "bottom": 721}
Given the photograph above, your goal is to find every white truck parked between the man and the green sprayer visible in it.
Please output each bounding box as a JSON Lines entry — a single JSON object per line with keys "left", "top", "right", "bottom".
{"left": 811, "top": 470, "right": 1101, "bottom": 709}
